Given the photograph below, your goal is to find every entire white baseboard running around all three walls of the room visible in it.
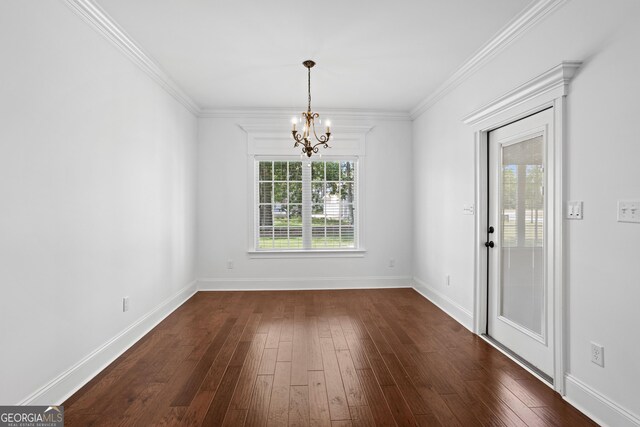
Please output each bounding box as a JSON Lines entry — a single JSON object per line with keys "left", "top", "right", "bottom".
{"left": 18, "top": 276, "right": 640, "bottom": 427}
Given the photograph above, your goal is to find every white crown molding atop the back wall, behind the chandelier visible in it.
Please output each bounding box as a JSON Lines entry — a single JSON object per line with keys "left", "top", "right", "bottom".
{"left": 199, "top": 108, "right": 411, "bottom": 121}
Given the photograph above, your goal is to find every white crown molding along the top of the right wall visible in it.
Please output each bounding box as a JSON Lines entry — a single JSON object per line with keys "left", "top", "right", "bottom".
{"left": 410, "top": 0, "right": 568, "bottom": 120}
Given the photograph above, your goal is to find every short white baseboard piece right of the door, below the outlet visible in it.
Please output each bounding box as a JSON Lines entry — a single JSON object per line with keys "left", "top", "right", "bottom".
{"left": 564, "top": 374, "right": 640, "bottom": 427}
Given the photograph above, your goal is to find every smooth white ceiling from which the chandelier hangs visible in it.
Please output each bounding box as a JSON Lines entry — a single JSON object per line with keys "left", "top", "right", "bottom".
{"left": 98, "top": 0, "right": 529, "bottom": 111}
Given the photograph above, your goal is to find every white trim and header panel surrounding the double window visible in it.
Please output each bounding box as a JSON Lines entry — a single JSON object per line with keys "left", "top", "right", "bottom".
{"left": 239, "top": 120, "right": 373, "bottom": 254}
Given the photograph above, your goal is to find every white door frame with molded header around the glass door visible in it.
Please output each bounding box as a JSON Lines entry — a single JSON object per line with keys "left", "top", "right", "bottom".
{"left": 462, "top": 61, "right": 582, "bottom": 395}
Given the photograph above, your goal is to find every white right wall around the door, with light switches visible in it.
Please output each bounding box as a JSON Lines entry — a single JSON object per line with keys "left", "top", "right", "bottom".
{"left": 413, "top": 0, "right": 640, "bottom": 425}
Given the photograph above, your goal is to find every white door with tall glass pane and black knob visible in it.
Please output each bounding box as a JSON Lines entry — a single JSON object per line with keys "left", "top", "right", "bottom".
{"left": 485, "top": 109, "right": 554, "bottom": 379}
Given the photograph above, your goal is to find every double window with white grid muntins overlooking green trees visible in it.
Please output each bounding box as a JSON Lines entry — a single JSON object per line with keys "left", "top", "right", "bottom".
{"left": 255, "top": 158, "right": 358, "bottom": 250}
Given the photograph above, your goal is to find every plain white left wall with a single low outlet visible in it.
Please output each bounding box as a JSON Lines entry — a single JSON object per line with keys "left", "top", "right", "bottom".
{"left": 0, "top": 0, "right": 197, "bottom": 404}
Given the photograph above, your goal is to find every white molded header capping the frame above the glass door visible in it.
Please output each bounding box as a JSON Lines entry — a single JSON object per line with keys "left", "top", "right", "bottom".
{"left": 462, "top": 61, "right": 582, "bottom": 126}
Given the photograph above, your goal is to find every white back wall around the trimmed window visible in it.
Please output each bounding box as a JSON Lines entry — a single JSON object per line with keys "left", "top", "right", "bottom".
{"left": 197, "top": 117, "right": 412, "bottom": 289}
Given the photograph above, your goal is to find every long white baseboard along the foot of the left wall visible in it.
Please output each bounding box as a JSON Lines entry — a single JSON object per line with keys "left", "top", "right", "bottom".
{"left": 18, "top": 281, "right": 196, "bottom": 405}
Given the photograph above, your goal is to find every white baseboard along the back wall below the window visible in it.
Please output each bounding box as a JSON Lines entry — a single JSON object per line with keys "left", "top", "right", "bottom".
{"left": 197, "top": 276, "right": 411, "bottom": 291}
